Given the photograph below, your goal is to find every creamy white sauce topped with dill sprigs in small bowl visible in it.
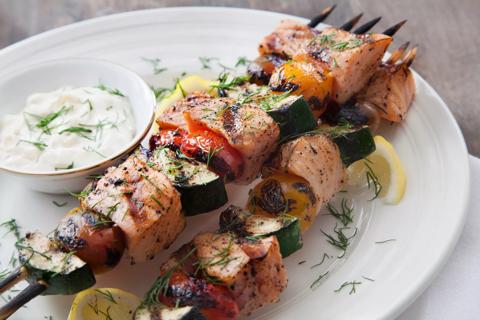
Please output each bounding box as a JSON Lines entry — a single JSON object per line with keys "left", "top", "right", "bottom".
{"left": 0, "top": 87, "right": 135, "bottom": 172}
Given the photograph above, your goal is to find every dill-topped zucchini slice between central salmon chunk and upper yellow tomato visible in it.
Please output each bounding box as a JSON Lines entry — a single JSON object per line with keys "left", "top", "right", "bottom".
{"left": 228, "top": 84, "right": 317, "bottom": 139}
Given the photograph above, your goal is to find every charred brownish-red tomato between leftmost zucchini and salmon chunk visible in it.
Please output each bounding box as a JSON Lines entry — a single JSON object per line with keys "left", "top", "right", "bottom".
{"left": 55, "top": 208, "right": 125, "bottom": 273}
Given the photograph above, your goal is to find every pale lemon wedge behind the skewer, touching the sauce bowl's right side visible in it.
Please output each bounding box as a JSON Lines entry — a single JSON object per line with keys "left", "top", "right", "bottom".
{"left": 154, "top": 75, "right": 217, "bottom": 131}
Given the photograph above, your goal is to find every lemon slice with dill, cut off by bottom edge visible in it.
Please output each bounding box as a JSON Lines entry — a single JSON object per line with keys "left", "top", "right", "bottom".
{"left": 68, "top": 288, "right": 140, "bottom": 320}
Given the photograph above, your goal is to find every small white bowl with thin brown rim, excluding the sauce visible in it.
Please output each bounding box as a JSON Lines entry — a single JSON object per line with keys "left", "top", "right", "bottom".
{"left": 0, "top": 58, "right": 156, "bottom": 193}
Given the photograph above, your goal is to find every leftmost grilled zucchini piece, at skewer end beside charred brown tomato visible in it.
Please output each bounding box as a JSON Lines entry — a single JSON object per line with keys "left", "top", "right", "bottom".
{"left": 16, "top": 232, "right": 95, "bottom": 295}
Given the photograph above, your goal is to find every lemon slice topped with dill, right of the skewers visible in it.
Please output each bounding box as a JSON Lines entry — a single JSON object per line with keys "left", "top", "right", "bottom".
{"left": 347, "top": 136, "right": 407, "bottom": 204}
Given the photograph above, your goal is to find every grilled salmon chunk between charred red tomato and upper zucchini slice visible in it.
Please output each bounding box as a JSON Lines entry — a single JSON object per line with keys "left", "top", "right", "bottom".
{"left": 188, "top": 98, "right": 280, "bottom": 183}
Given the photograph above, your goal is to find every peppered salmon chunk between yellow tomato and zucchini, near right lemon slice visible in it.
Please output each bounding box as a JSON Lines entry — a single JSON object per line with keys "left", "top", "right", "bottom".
{"left": 263, "top": 134, "right": 345, "bottom": 206}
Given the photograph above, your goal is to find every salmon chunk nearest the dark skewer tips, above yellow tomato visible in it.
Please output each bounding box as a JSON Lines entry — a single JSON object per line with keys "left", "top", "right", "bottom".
{"left": 305, "top": 28, "right": 392, "bottom": 104}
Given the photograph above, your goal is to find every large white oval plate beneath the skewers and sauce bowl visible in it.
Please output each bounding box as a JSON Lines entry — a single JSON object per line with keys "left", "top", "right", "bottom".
{"left": 0, "top": 8, "right": 469, "bottom": 319}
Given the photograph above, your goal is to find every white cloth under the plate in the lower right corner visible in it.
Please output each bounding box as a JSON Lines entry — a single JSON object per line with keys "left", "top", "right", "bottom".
{"left": 397, "top": 156, "right": 480, "bottom": 320}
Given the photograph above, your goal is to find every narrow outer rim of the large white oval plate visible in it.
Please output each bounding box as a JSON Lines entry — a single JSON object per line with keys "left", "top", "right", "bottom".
{"left": 0, "top": 6, "right": 471, "bottom": 318}
